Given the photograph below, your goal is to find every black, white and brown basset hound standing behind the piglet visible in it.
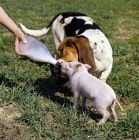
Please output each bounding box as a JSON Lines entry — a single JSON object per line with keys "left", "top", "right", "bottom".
{"left": 20, "top": 12, "right": 113, "bottom": 82}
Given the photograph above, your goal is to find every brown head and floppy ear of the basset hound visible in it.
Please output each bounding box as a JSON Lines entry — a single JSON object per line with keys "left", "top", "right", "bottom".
{"left": 58, "top": 36, "right": 96, "bottom": 73}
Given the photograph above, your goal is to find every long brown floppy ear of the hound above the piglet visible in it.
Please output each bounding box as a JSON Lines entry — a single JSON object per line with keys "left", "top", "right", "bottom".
{"left": 74, "top": 36, "right": 96, "bottom": 73}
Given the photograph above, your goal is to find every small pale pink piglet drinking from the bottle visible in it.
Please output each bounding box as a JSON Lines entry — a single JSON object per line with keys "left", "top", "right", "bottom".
{"left": 61, "top": 62, "right": 123, "bottom": 124}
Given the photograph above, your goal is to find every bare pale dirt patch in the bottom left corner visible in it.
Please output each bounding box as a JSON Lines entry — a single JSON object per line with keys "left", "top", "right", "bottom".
{"left": 0, "top": 103, "right": 25, "bottom": 140}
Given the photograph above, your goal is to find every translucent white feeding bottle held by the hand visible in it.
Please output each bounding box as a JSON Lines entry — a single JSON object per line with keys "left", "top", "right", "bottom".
{"left": 19, "top": 36, "right": 57, "bottom": 65}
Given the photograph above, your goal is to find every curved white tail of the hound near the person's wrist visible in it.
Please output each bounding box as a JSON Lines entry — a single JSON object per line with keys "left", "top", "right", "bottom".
{"left": 20, "top": 23, "right": 51, "bottom": 36}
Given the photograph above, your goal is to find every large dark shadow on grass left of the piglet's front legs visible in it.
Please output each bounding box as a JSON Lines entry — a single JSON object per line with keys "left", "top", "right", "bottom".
{"left": 34, "top": 75, "right": 73, "bottom": 107}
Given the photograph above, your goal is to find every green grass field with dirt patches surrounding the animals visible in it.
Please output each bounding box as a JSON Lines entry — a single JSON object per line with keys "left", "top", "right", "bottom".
{"left": 0, "top": 0, "right": 139, "bottom": 140}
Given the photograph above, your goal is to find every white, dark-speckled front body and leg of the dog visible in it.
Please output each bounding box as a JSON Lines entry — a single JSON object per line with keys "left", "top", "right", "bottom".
{"left": 79, "top": 29, "right": 113, "bottom": 82}
